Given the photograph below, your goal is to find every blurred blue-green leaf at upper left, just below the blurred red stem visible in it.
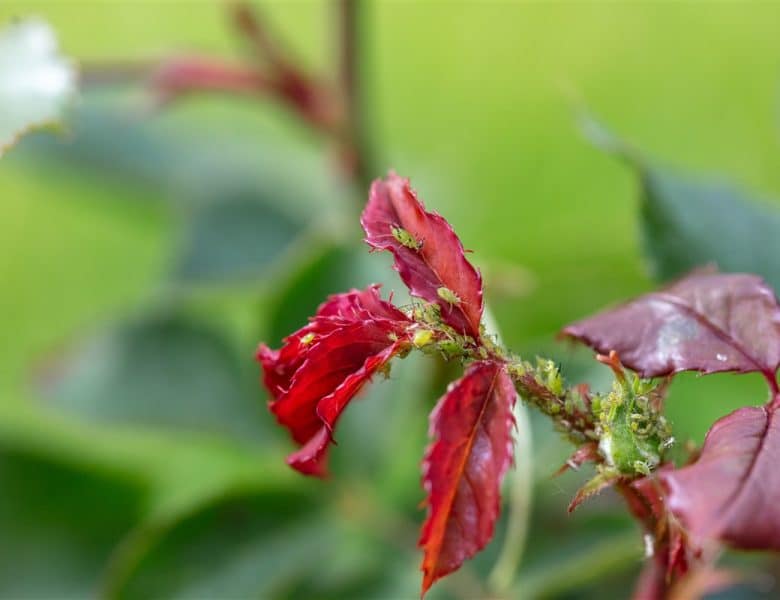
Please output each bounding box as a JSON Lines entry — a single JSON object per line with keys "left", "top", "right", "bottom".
{"left": 17, "top": 99, "right": 349, "bottom": 221}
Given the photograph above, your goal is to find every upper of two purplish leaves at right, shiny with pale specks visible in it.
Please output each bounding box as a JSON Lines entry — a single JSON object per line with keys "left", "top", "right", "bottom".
{"left": 562, "top": 273, "right": 780, "bottom": 378}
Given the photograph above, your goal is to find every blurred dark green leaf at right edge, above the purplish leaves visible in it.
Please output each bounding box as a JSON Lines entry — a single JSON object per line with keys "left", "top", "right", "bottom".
{"left": 585, "top": 119, "right": 780, "bottom": 290}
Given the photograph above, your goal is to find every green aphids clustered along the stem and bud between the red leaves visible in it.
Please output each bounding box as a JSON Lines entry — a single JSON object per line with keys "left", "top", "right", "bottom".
{"left": 391, "top": 227, "right": 673, "bottom": 480}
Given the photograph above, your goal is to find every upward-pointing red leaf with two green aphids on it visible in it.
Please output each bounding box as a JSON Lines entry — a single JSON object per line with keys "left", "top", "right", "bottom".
{"left": 360, "top": 173, "right": 482, "bottom": 340}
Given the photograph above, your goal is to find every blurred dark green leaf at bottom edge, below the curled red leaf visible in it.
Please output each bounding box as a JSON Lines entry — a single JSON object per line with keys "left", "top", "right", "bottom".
{"left": 119, "top": 495, "right": 330, "bottom": 598}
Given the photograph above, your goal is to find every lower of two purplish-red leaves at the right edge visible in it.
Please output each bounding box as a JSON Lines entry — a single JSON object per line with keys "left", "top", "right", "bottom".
{"left": 661, "top": 396, "right": 780, "bottom": 550}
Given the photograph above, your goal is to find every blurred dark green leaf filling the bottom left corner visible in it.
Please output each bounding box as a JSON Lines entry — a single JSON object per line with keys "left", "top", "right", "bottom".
{"left": 0, "top": 450, "right": 143, "bottom": 599}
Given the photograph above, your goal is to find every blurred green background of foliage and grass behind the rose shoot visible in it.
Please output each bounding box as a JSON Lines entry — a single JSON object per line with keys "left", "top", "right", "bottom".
{"left": 0, "top": 0, "right": 780, "bottom": 598}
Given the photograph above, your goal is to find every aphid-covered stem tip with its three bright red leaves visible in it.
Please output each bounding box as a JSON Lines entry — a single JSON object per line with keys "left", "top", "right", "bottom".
{"left": 258, "top": 173, "right": 700, "bottom": 593}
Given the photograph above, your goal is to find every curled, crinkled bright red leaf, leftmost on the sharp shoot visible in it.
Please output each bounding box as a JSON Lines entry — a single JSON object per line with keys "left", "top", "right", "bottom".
{"left": 257, "top": 286, "right": 412, "bottom": 475}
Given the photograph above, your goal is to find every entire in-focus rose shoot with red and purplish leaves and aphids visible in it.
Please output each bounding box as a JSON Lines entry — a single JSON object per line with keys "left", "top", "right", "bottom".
{"left": 257, "top": 173, "right": 780, "bottom": 598}
